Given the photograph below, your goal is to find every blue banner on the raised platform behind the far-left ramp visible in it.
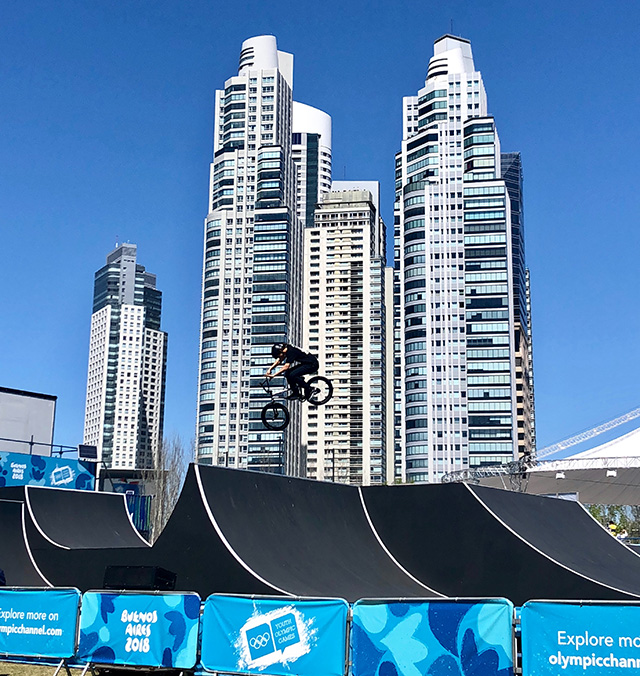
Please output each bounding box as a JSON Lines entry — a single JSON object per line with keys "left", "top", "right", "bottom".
{"left": 0, "top": 451, "right": 95, "bottom": 491}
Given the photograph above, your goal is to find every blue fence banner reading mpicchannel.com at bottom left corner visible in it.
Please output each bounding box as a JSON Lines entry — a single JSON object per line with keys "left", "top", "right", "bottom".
{"left": 0, "top": 589, "right": 80, "bottom": 659}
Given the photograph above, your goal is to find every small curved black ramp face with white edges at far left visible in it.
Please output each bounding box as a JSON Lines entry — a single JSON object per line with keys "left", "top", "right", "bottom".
{"left": 26, "top": 486, "right": 148, "bottom": 549}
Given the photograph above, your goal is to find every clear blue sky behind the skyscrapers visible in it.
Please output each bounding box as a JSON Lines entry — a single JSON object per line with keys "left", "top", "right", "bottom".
{"left": 0, "top": 0, "right": 640, "bottom": 460}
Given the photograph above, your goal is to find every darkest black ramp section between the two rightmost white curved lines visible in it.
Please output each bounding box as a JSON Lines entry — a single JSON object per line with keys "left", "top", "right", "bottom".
{"left": 361, "top": 484, "right": 640, "bottom": 605}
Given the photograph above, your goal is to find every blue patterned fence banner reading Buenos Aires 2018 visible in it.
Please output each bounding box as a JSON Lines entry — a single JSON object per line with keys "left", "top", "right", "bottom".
{"left": 77, "top": 592, "right": 200, "bottom": 669}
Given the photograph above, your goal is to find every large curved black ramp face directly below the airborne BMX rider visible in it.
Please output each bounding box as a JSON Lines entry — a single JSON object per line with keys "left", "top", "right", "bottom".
{"left": 196, "top": 466, "right": 438, "bottom": 601}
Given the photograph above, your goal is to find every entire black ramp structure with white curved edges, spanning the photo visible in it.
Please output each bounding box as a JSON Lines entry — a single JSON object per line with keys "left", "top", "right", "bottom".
{"left": 0, "top": 465, "right": 640, "bottom": 604}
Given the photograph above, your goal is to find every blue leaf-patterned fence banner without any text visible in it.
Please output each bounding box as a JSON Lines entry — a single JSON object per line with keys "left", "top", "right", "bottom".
{"left": 351, "top": 599, "right": 513, "bottom": 676}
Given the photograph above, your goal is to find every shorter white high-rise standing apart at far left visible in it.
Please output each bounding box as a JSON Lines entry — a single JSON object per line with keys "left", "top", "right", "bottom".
{"left": 84, "top": 244, "right": 167, "bottom": 475}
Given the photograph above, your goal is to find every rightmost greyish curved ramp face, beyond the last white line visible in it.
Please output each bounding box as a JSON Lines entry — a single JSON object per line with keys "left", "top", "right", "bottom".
{"left": 470, "top": 486, "right": 640, "bottom": 596}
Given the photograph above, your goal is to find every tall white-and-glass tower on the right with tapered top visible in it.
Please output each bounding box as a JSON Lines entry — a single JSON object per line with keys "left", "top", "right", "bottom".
{"left": 394, "top": 35, "right": 533, "bottom": 482}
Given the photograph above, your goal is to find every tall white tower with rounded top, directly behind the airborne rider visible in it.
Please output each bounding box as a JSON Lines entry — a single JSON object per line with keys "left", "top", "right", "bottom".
{"left": 196, "top": 35, "right": 330, "bottom": 475}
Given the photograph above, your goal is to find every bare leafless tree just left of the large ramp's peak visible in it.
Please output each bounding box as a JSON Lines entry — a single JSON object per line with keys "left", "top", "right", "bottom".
{"left": 142, "top": 434, "right": 189, "bottom": 543}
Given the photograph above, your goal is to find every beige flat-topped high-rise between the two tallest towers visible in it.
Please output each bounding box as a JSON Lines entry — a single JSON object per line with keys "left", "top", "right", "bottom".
{"left": 303, "top": 181, "right": 393, "bottom": 485}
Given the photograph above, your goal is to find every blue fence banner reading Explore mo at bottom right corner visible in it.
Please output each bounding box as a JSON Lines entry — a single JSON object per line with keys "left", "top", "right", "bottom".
{"left": 521, "top": 601, "right": 640, "bottom": 676}
